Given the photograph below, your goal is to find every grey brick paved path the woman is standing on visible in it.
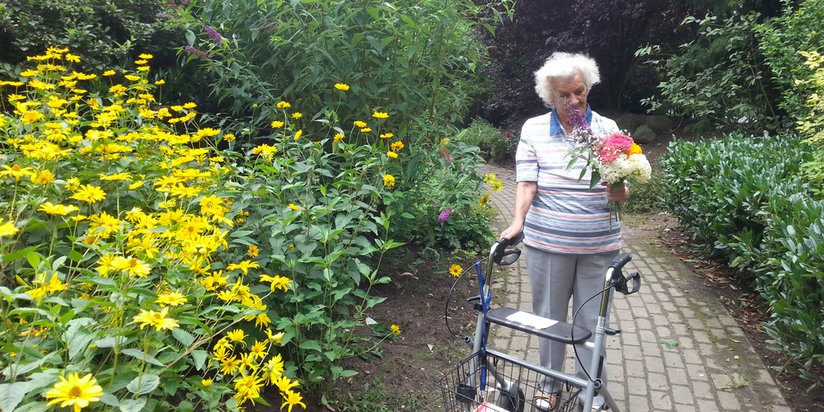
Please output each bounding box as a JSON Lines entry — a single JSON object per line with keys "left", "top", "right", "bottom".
{"left": 487, "top": 166, "right": 791, "bottom": 412}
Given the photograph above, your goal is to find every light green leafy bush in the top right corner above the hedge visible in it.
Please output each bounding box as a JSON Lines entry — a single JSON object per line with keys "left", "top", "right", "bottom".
{"left": 756, "top": 0, "right": 824, "bottom": 122}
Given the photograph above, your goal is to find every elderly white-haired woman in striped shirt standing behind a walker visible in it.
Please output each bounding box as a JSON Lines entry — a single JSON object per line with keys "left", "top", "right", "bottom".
{"left": 501, "top": 53, "right": 629, "bottom": 411}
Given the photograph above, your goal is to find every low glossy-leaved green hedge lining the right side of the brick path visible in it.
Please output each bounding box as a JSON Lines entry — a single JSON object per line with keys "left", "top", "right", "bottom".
{"left": 661, "top": 135, "right": 824, "bottom": 385}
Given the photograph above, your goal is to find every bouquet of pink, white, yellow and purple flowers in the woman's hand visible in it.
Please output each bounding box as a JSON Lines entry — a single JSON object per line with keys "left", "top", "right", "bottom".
{"left": 567, "top": 106, "right": 652, "bottom": 224}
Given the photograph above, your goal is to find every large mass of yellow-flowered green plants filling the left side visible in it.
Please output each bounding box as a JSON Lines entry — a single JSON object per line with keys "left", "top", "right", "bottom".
{"left": 0, "top": 48, "right": 418, "bottom": 410}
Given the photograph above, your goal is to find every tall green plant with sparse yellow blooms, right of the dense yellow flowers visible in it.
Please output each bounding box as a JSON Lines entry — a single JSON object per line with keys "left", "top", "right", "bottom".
{"left": 225, "top": 103, "right": 406, "bottom": 391}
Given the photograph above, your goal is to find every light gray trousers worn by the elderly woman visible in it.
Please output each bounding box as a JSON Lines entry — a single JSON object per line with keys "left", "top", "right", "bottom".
{"left": 526, "top": 246, "right": 618, "bottom": 392}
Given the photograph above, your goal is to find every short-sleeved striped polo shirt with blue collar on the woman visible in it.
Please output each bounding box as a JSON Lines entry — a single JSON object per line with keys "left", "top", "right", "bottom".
{"left": 515, "top": 107, "right": 621, "bottom": 254}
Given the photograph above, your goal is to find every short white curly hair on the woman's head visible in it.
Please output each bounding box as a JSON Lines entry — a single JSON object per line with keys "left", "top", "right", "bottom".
{"left": 535, "top": 52, "right": 601, "bottom": 106}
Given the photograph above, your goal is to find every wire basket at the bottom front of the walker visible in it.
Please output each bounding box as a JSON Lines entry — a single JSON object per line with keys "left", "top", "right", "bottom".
{"left": 437, "top": 353, "right": 581, "bottom": 412}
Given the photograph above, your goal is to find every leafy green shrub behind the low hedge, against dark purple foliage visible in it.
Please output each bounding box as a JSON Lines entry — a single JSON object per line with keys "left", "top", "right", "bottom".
{"left": 645, "top": 13, "right": 777, "bottom": 132}
